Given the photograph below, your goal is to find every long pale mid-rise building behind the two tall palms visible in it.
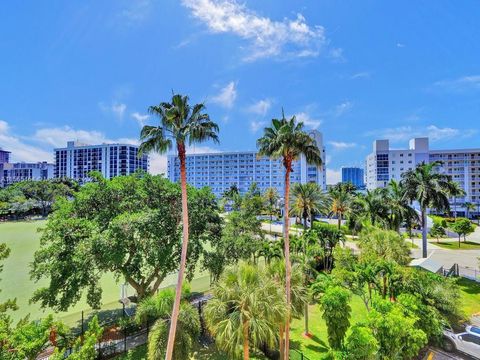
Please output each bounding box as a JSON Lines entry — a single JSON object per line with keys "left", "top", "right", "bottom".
{"left": 167, "top": 131, "right": 326, "bottom": 196}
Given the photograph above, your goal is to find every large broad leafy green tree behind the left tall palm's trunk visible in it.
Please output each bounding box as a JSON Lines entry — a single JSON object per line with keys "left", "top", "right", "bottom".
{"left": 31, "top": 174, "right": 221, "bottom": 311}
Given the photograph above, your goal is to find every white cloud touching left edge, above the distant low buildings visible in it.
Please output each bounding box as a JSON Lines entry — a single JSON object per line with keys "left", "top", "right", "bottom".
{"left": 0, "top": 120, "right": 53, "bottom": 162}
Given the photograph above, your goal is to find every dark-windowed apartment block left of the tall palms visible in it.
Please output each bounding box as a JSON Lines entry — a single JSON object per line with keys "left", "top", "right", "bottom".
{"left": 54, "top": 141, "right": 149, "bottom": 182}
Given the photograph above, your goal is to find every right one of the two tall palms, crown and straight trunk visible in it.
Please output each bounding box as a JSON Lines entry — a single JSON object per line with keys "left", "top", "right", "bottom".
{"left": 257, "top": 111, "right": 322, "bottom": 359}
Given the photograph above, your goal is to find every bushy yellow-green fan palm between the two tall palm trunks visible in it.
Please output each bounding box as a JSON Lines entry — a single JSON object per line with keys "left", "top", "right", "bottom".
{"left": 204, "top": 262, "right": 286, "bottom": 359}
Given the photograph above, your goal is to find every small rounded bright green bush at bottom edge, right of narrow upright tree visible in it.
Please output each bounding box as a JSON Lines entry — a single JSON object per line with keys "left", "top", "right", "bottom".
{"left": 345, "top": 325, "right": 379, "bottom": 360}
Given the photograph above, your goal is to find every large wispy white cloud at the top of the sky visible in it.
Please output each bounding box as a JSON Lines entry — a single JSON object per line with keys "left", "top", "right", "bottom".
{"left": 183, "top": 0, "right": 326, "bottom": 61}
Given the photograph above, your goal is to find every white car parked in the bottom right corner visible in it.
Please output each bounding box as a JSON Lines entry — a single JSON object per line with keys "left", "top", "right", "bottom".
{"left": 443, "top": 326, "right": 480, "bottom": 359}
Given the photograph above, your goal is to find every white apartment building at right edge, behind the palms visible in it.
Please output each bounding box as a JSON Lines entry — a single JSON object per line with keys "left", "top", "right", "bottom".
{"left": 366, "top": 137, "right": 480, "bottom": 216}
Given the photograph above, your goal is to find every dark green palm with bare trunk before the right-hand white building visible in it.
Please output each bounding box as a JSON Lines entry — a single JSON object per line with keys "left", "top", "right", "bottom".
{"left": 402, "top": 161, "right": 452, "bottom": 258}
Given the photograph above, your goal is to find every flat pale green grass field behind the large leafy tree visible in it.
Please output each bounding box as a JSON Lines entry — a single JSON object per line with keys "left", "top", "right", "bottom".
{"left": 0, "top": 221, "right": 210, "bottom": 326}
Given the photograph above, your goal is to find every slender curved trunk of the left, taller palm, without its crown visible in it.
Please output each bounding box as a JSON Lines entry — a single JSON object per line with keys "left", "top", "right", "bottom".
{"left": 165, "top": 144, "right": 188, "bottom": 360}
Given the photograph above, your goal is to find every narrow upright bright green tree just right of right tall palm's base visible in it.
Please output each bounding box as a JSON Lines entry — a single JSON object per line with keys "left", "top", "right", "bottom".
{"left": 320, "top": 286, "right": 352, "bottom": 350}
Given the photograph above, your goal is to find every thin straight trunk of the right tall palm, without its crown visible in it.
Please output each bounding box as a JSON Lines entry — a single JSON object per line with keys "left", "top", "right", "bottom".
{"left": 283, "top": 159, "right": 292, "bottom": 360}
